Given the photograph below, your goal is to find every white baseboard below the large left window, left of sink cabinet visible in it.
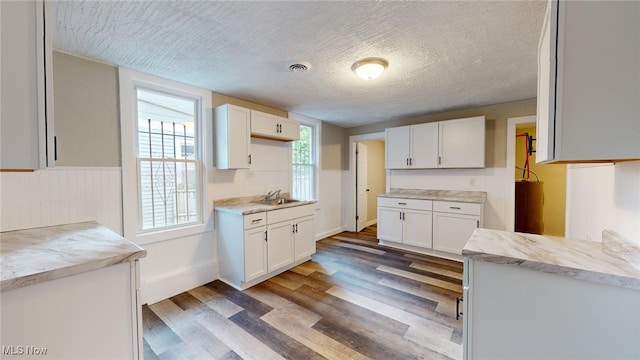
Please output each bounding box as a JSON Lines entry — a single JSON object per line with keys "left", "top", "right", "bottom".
{"left": 140, "top": 261, "right": 218, "bottom": 304}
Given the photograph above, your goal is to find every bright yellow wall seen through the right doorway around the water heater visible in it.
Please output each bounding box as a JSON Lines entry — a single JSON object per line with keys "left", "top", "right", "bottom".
{"left": 515, "top": 126, "right": 567, "bottom": 236}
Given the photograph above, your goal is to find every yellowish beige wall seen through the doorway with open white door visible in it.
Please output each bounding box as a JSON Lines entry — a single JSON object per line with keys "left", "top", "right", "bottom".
{"left": 362, "top": 140, "right": 387, "bottom": 221}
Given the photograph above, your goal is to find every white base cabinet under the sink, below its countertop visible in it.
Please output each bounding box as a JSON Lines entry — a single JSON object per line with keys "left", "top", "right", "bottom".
{"left": 216, "top": 205, "right": 316, "bottom": 290}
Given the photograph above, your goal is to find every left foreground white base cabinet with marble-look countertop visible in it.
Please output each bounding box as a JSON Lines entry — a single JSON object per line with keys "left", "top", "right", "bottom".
{"left": 0, "top": 222, "right": 146, "bottom": 359}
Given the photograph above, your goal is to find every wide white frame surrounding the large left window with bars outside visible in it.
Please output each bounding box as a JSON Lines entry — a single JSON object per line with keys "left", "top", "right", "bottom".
{"left": 119, "top": 68, "right": 213, "bottom": 244}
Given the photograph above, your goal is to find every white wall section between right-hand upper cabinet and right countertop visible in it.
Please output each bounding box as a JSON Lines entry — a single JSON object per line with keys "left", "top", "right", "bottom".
{"left": 565, "top": 161, "right": 640, "bottom": 245}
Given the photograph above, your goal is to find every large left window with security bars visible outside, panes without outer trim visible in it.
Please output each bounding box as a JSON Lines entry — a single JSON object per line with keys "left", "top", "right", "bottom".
{"left": 136, "top": 87, "right": 200, "bottom": 230}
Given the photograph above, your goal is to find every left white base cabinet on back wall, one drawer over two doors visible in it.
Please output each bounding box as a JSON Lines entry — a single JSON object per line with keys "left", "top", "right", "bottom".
{"left": 378, "top": 198, "right": 432, "bottom": 248}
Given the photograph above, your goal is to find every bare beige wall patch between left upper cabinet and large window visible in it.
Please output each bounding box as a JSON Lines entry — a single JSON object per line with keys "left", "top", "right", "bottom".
{"left": 53, "top": 51, "right": 120, "bottom": 167}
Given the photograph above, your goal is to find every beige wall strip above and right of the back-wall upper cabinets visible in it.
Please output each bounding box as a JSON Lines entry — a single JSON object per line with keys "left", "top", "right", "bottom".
{"left": 345, "top": 99, "right": 536, "bottom": 168}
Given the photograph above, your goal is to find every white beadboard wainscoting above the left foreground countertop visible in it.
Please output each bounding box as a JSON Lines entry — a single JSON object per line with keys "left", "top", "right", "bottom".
{"left": 0, "top": 167, "right": 122, "bottom": 234}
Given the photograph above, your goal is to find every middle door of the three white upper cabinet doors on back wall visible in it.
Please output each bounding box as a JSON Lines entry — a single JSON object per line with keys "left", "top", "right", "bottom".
{"left": 409, "top": 122, "right": 438, "bottom": 169}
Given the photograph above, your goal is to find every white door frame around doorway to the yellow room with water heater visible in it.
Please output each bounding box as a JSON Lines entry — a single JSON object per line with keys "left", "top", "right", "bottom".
{"left": 504, "top": 115, "right": 536, "bottom": 231}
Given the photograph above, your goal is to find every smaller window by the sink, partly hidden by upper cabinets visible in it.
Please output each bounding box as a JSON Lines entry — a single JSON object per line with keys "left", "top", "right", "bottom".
{"left": 292, "top": 124, "right": 316, "bottom": 200}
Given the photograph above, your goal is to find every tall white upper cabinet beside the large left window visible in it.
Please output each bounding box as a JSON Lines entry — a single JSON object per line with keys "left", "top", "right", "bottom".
{"left": 215, "top": 104, "right": 251, "bottom": 169}
